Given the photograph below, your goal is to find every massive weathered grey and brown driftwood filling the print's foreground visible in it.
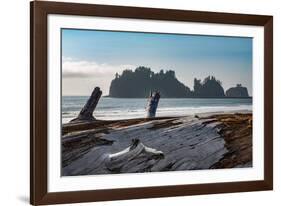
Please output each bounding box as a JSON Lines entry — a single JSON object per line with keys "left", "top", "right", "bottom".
{"left": 62, "top": 110, "right": 252, "bottom": 176}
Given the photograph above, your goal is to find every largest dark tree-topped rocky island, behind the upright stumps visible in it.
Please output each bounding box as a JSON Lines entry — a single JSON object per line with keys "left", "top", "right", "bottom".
{"left": 109, "top": 67, "right": 191, "bottom": 98}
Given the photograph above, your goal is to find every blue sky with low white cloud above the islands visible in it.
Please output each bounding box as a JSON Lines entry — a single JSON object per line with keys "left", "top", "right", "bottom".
{"left": 62, "top": 29, "right": 252, "bottom": 96}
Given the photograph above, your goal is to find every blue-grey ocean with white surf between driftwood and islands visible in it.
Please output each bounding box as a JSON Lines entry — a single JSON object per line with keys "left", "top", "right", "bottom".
{"left": 62, "top": 96, "right": 252, "bottom": 123}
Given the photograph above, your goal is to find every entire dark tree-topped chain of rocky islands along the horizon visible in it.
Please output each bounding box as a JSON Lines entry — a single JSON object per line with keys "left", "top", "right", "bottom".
{"left": 108, "top": 66, "right": 250, "bottom": 98}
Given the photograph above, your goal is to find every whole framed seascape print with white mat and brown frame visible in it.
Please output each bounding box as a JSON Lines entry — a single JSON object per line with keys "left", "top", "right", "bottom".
{"left": 30, "top": 1, "right": 273, "bottom": 205}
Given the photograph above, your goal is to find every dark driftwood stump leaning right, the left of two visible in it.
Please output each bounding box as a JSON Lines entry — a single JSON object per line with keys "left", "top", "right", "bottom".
{"left": 71, "top": 87, "right": 102, "bottom": 122}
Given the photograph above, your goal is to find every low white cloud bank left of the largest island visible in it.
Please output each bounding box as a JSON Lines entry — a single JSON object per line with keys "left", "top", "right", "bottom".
{"left": 62, "top": 57, "right": 135, "bottom": 78}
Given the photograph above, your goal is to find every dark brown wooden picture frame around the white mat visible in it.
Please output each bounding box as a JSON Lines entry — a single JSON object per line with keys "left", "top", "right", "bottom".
{"left": 30, "top": 1, "right": 273, "bottom": 205}
